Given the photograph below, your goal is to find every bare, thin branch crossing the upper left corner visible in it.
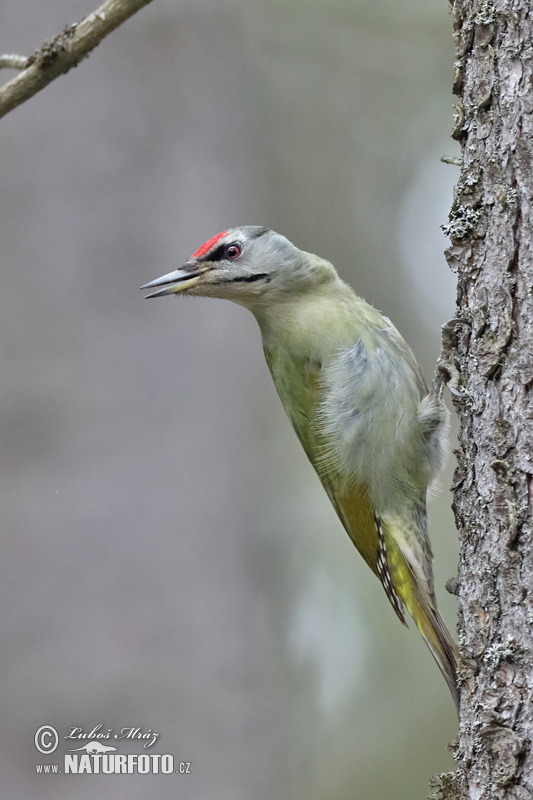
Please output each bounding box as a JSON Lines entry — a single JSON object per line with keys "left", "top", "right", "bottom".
{"left": 0, "top": 0, "right": 152, "bottom": 117}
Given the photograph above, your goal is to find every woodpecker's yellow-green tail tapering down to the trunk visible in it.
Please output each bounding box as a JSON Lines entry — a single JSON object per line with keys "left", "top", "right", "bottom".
{"left": 380, "top": 524, "right": 459, "bottom": 714}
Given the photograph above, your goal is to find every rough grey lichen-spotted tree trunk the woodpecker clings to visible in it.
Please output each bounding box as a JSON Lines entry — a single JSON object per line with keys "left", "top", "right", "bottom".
{"left": 437, "top": 0, "right": 533, "bottom": 800}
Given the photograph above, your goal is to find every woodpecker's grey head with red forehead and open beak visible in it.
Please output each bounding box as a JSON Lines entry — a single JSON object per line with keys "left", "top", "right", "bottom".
{"left": 141, "top": 230, "right": 336, "bottom": 308}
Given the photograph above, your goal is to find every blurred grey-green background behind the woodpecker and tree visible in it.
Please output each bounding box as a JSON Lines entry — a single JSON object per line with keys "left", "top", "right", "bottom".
{"left": 0, "top": 0, "right": 456, "bottom": 800}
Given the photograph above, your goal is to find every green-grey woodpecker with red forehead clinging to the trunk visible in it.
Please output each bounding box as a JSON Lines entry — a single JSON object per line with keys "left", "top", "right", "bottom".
{"left": 141, "top": 226, "right": 458, "bottom": 707}
